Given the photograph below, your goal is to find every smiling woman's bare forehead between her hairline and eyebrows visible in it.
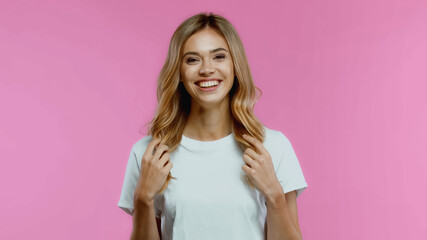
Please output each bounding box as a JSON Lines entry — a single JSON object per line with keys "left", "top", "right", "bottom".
{"left": 183, "top": 28, "right": 229, "bottom": 53}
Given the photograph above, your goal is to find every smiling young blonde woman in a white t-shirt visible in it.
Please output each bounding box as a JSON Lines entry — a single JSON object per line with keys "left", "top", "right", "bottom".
{"left": 118, "top": 13, "right": 307, "bottom": 240}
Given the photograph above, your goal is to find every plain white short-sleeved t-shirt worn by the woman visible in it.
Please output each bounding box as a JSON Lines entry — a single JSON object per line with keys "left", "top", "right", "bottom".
{"left": 117, "top": 127, "right": 307, "bottom": 240}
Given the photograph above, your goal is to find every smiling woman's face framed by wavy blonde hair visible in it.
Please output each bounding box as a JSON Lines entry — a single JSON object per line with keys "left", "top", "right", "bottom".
{"left": 180, "top": 28, "right": 234, "bottom": 107}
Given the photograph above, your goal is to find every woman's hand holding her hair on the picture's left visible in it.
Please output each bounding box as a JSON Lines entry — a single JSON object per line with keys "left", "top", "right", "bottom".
{"left": 134, "top": 138, "right": 173, "bottom": 205}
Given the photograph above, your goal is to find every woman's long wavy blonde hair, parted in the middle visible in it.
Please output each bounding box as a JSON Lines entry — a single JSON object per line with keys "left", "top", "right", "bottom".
{"left": 144, "top": 12, "right": 265, "bottom": 192}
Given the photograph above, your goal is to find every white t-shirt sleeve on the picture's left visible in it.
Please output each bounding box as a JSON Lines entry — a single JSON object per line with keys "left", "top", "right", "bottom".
{"left": 117, "top": 142, "right": 161, "bottom": 218}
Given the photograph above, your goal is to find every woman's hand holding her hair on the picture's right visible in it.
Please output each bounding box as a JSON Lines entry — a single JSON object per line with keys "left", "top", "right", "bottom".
{"left": 242, "top": 134, "right": 282, "bottom": 196}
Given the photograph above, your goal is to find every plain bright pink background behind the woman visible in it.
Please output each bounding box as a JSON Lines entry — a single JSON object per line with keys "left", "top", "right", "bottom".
{"left": 0, "top": 0, "right": 427, "bottom": 240}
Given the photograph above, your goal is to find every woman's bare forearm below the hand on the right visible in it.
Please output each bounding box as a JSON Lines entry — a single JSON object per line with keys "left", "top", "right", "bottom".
{"left": 265, "top": 189, "right": 302, "bottom": 240}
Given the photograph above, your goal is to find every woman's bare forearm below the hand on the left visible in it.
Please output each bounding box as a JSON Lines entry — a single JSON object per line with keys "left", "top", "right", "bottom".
{"left": 130, "top": 200, "right": 160, "bottom": 240}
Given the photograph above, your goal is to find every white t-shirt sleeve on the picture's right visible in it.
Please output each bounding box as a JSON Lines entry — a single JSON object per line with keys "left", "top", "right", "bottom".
{"left": 276, "top": 132, "right": 308, "bottom": 198}
